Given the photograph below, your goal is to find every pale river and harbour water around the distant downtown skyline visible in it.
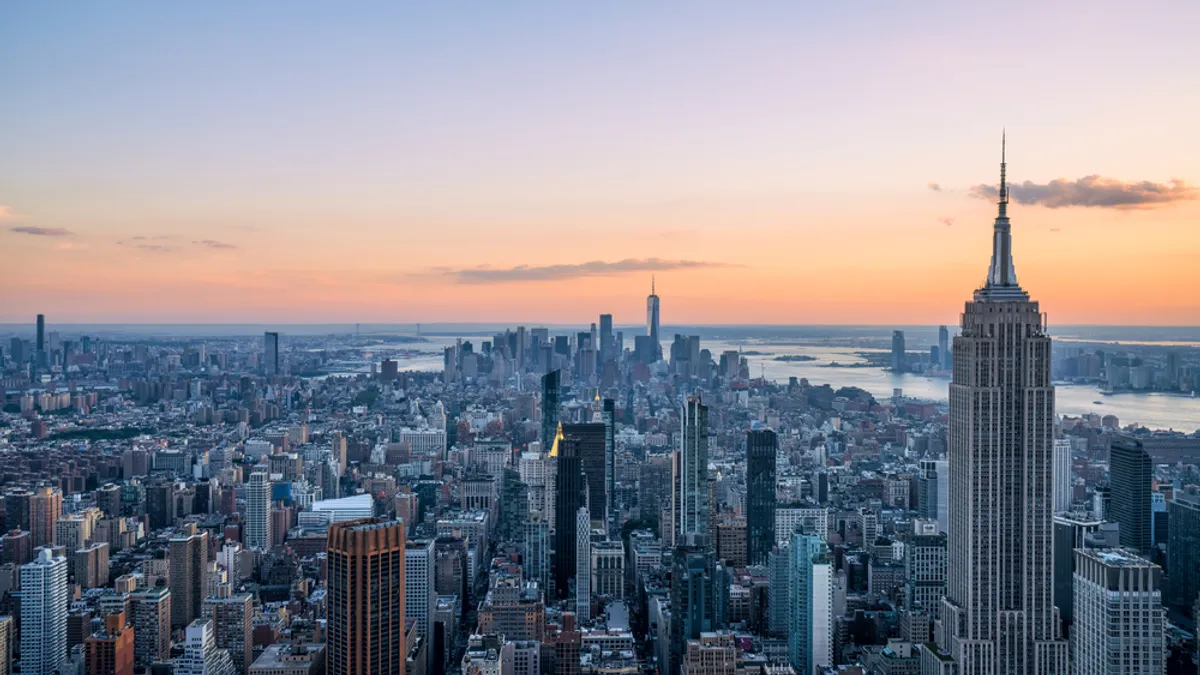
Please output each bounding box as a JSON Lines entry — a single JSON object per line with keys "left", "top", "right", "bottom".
{"left": 319, "top": 335, "right": 1200, "bottom": 432}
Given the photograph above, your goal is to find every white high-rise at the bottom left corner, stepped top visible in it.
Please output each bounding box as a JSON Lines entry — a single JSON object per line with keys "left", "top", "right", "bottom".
{"left": 20, "top": 549, "right": 70, "bottom": 675}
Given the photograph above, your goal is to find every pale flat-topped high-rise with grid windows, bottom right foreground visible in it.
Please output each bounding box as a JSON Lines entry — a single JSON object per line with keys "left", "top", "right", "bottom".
{"left": 1070, "top": 549, "right": 1166, "bottom": 675}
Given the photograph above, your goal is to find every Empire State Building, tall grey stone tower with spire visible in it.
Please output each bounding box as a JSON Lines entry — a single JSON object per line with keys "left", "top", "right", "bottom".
{"left": 922, "top": 133, "right": 1068, "bottom": 675}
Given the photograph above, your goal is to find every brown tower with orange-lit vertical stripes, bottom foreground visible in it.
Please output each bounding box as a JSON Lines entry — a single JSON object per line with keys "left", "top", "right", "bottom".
{"left": 325, "top": 518, "right": 406, "bottom": 675}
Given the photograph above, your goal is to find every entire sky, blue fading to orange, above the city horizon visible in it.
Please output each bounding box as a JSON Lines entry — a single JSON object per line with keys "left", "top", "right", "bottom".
{"left": 0, "top": 0, "right": 1200, "bottom": 325}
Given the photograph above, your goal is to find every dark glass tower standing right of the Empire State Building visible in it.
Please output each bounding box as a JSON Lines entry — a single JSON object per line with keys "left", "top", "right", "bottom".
{"left": 1109, "top": 436, "right": 1154, "bottom": 552}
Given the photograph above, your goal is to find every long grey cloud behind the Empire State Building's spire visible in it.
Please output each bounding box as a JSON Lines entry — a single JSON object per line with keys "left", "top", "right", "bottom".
{"left": 971, "top": 174, "right": 1200, "bottom": 209}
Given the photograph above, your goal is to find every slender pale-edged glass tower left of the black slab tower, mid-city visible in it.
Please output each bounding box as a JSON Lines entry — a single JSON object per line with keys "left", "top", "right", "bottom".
{"left": 672, "top": 396, "right": 708, "bottom": 545}
